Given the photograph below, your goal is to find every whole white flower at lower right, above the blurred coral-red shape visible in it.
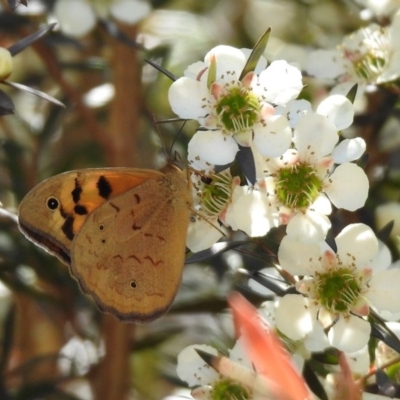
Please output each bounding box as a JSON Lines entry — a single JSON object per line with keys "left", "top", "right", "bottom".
{"left": 276, "top": 224, "right": 400, "bottom": 352}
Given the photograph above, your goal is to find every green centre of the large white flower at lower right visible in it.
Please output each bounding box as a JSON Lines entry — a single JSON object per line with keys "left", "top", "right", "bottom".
{"left": 315, "top": 267, "right": 361, "bottom": 313}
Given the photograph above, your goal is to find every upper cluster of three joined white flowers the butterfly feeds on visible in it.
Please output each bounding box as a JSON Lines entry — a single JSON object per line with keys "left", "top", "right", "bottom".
{"left": 169, "top": 46, "right": 369, "bottom": 251}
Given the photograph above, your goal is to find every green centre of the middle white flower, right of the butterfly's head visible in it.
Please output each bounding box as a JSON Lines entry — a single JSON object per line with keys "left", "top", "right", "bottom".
{"left": 276, "top": 163, "right": 322, "bottom": 210}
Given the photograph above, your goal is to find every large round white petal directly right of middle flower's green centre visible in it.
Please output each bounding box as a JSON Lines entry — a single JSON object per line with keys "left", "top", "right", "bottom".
{"left": 324, "top": 163, "right": 369, "bottom": 211}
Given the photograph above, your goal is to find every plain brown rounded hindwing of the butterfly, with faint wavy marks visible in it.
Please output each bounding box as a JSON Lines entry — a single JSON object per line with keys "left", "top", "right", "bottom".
{"left": 71, "top": 165, "right": 191, "bottom": 322}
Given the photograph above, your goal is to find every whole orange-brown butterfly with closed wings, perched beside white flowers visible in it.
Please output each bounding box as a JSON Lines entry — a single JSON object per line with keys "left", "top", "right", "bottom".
{"left": 18, "top": 160, "right": 192, "bottom": 323}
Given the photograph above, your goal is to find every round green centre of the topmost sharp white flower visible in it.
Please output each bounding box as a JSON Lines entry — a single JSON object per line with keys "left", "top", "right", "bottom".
{"left": 215, "top": 87, "right": 260, "bottom": 133}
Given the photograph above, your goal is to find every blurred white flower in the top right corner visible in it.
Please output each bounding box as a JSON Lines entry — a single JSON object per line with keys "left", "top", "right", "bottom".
{"left": 306, "top": 12, "right": 400, "bottom": 84}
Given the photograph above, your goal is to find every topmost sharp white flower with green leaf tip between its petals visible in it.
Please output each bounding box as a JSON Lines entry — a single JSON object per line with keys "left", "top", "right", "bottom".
{"left": 168, "top": 46, "right": 303, "bottom": 165}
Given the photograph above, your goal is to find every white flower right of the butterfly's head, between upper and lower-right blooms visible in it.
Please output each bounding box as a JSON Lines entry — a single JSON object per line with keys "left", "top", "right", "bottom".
{"left": 258, "top": 114, "right": 369, "bottom": 242}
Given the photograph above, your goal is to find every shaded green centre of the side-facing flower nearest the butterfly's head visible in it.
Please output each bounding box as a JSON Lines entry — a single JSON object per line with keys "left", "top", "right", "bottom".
{"left": 201, "top": 170, "right": 232, "bottom": 216}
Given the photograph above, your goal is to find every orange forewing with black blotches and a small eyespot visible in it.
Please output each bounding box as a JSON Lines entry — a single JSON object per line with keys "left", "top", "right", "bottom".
{"left": 18, "top": 168, "right": 162, "bottom": 265}
